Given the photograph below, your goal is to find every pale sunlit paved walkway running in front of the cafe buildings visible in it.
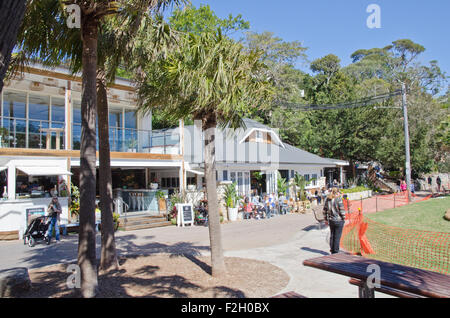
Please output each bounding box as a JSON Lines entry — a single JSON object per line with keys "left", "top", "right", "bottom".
{"left": 0, "top": 214, "right": 390, "bottom": 298}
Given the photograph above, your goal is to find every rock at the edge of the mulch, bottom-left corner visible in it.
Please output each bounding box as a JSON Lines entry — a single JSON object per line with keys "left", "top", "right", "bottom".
{"left": 0, "top": 267, "right": 31, "bottom": 297}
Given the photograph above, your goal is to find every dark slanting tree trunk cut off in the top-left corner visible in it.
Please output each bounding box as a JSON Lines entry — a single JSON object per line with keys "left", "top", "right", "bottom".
{"left": 0, "top": 0, "right": 26, "bottom": 92}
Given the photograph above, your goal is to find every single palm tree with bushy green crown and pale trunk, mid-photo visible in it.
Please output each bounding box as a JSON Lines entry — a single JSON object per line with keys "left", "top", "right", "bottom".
{"left": 137, "top": 30, "right": 268, "bottom": 277}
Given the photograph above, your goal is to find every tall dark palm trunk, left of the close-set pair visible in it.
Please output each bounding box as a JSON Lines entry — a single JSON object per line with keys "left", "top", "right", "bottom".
{"left": 78, "top": 16, "right": 98, "bottom": 298}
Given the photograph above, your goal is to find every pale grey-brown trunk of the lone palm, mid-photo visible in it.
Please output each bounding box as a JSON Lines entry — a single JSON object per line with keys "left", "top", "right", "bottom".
{"left": 203, "top": 115, "right": 226, "bottom": 277}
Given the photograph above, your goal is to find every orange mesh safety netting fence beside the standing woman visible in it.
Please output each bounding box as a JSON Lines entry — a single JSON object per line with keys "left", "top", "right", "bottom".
{"left": 341, "top": 196, "right": 450, "bottom": 274}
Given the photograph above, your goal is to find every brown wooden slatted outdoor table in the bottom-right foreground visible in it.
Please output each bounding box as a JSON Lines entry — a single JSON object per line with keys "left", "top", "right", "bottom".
{"left": 303, "top": 253, "right": 450, "bottom": 298}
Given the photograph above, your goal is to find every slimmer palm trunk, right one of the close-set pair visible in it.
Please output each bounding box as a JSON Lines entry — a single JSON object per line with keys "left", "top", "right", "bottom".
{"left": 97, "top": 69, "right": 119, "bottom": 271}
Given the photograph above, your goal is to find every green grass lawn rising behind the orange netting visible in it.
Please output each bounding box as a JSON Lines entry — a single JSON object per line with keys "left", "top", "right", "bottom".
{"left": 366, "top": 197, "right": 450, "bottom": 233}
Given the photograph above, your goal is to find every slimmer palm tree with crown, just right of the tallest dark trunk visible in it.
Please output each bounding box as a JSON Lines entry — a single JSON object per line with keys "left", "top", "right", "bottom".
{"left": 97, "top": 0, "right": 181, "bottom": 271}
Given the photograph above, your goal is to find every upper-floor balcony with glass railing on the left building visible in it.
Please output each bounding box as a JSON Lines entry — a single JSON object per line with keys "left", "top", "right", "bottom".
{"left": 0, "top": 117, "right": 180, "bottom": 155}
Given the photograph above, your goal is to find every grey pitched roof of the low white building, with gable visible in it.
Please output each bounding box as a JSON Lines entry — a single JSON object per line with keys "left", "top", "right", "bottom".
{"left": 184, "top": 118, "right": 336, "bottom": 167}
